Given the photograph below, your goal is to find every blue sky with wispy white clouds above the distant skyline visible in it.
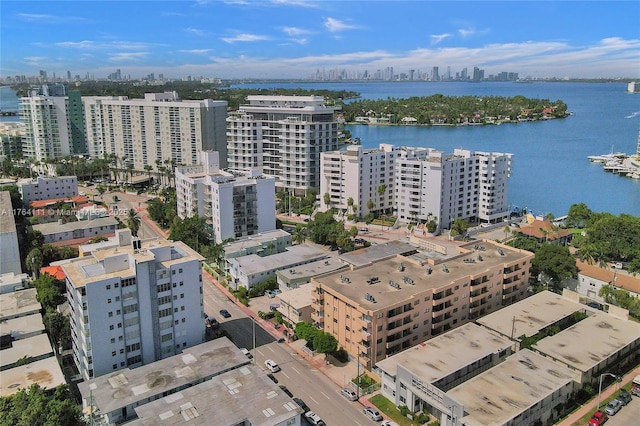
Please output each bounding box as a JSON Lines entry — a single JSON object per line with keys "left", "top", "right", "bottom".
{"left": 0, "top": 0, "right": 640, "bottom": 78}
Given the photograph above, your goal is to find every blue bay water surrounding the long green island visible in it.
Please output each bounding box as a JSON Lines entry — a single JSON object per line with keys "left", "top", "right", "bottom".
{"left": 238, "top": 82, "right": 640, "bottom": 216}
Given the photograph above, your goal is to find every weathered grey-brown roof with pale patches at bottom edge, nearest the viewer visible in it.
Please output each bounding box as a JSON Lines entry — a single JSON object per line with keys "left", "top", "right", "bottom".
{"left": 130, "top": 364, "right": 302, "bottom": 426}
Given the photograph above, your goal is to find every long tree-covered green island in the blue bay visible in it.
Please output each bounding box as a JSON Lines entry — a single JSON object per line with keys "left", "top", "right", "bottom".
{"left": 342, "top": 95, "right": 571, "bottom": 126}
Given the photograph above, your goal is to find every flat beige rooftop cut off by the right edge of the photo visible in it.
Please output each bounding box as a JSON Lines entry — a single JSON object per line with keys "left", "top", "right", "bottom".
{"left": 535, "top": 312, "right": 640, "bottom": 372}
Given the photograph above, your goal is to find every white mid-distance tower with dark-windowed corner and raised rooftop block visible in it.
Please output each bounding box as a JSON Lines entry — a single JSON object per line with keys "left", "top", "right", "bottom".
{"left": 176, "top": 151, "right": 276, "bottom": 243}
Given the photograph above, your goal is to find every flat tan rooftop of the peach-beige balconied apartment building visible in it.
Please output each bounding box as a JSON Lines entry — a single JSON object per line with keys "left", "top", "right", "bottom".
{"left": 313, "top": 242, "right": 532, "bottom": 311}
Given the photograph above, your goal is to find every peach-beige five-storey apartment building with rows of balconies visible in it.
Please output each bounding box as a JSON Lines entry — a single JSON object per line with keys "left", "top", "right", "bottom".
{"left": 311, "top": 241, "right": 534, "bottom": 369}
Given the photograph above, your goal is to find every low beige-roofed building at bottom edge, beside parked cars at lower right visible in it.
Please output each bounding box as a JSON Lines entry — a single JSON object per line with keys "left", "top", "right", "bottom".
{"left": 440, "top": 349, "right": 576, "bottom": 426}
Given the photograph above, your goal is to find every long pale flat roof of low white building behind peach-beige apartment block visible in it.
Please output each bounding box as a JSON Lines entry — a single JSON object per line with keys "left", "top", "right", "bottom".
{"left": 230, "top": 244, "right": 327, "bottom": 275}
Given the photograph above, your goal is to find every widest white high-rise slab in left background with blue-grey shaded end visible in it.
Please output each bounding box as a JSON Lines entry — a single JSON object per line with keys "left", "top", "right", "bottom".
{"left": 82, "top": 92, "right": 227, "bottom": 171}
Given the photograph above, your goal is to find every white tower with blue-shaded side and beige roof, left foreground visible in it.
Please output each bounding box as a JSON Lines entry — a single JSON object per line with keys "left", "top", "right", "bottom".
{"left": 62, "top": 234, "right": 205, "bottom": 380}
